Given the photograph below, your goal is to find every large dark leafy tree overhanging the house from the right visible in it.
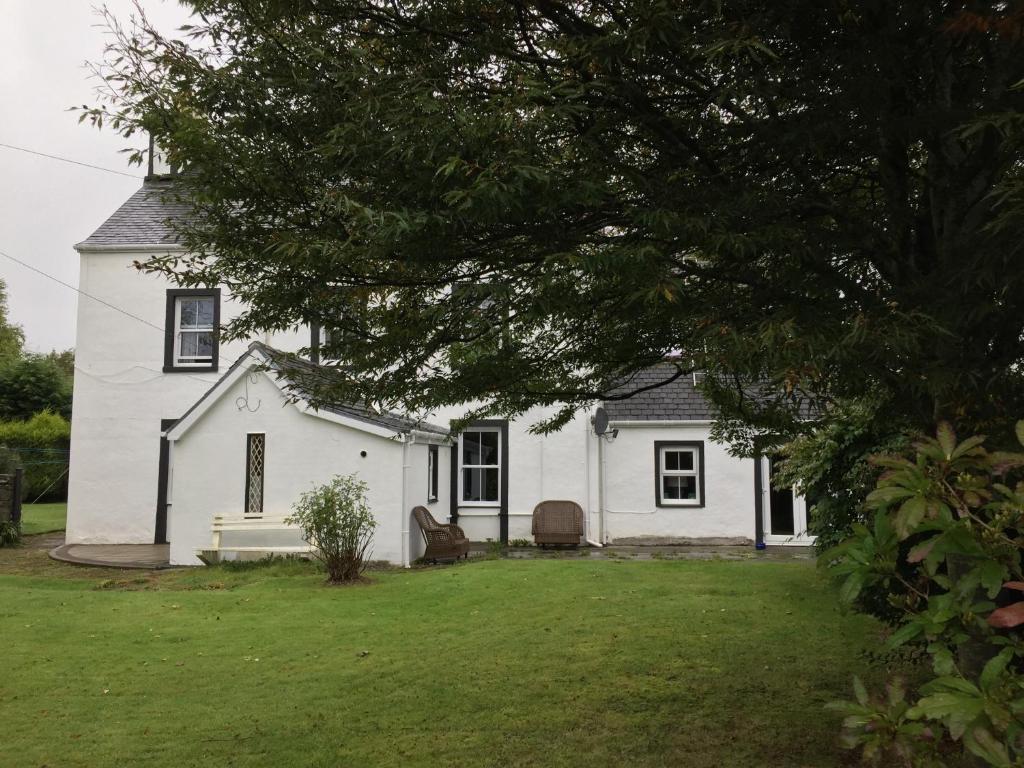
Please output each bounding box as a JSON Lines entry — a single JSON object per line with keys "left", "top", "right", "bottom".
{"left": 87, "top": 0, "right": 1024, "bottom": 442}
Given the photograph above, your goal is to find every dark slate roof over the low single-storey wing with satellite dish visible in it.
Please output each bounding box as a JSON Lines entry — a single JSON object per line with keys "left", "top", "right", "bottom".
{"left": 603, "top": 362, "right": 717, "bottom": 421}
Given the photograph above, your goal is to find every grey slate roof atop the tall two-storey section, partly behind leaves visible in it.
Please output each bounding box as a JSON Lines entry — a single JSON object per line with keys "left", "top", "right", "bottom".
{"left": 76, "top": 179, "right": 188, "bottom": 248}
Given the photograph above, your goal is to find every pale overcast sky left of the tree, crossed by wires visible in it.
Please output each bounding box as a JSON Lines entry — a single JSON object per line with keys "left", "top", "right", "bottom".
{"left": 0, "top": 0, "right": 186, "bottom": 351}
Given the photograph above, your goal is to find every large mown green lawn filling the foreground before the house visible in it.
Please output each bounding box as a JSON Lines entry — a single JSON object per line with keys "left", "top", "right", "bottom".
{"left": 0, "top": 549, "right": 881, "bottom": 768}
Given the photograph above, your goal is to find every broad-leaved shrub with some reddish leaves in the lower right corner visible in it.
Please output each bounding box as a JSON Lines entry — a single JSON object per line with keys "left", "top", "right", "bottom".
{"left": 822, "top": 422, "right": 1024, "bottom": 768}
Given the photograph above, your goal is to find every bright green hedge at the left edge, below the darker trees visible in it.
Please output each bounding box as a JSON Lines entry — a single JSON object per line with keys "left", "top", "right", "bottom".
{"left": 0, "top": 412, "right": 71, "bottom": 501}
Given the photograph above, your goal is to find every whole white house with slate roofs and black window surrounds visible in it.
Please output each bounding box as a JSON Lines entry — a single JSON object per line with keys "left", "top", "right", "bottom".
{"left": 68, "top": 175, "right": 810, "bottom": 564}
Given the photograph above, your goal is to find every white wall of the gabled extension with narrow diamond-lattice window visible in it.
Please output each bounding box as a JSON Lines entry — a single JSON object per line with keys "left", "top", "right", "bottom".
{"left": 168, "top": 373, "right": 427, "bottom": 565}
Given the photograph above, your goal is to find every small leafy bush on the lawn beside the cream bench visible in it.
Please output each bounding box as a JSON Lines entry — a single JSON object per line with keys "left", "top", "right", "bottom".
{"left": 288, "top": 475, "right": 377, "bottom": 583}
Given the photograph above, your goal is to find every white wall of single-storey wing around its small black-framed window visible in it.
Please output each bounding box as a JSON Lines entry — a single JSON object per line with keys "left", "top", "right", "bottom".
{"left": 604, "top": 425, "right": 755, "bottom": 543}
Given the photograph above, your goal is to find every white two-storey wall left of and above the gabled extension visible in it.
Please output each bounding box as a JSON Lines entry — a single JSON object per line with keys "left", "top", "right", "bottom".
{"left": 68, "top": 247, "right": 308, "bottom": 543}
